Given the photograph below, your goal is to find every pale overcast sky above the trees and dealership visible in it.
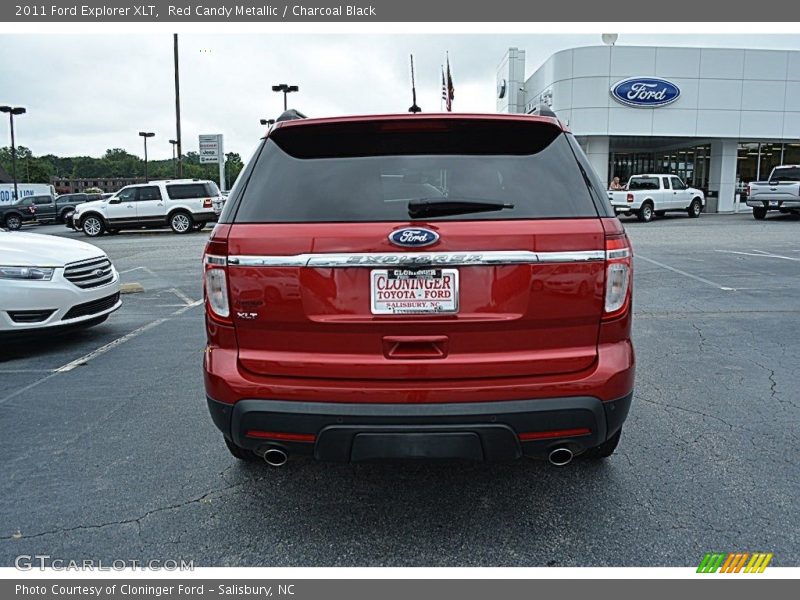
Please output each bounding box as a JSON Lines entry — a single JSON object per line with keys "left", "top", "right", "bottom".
{"left": 0, "top": 33, "right": 800, "bottom": 160}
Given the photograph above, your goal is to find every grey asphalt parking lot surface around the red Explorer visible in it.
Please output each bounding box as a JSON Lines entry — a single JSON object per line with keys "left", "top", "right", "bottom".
{"left": 0, "top": 215, "right": 800, "bottom": 566}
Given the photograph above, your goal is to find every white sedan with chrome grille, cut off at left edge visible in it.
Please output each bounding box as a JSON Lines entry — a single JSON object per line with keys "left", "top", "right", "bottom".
{"left": 0, "top": 229, "right": 122, "bottom": 337}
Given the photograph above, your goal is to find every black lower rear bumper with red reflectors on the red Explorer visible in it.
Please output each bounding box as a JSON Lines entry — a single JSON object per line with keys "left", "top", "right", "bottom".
{"left": 207, "top": 392, "right": 633, "bottom": 462}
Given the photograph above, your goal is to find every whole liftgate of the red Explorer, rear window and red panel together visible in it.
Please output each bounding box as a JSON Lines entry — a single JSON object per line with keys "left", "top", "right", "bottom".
{"left": 221, "top": 116, "right": 613, "bottom": 380}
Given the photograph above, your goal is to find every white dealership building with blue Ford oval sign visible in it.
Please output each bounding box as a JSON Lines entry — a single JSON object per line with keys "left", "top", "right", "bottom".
{"left": 497, "top": 45, "right": 800, "bottom": 212}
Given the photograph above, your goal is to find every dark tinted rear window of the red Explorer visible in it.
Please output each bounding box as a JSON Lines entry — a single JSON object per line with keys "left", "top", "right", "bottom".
{"left": 234, "top": 120, "right": 598, "bottom": 223}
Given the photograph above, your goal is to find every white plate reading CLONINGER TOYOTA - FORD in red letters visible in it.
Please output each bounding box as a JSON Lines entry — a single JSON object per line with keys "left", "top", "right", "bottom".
{"left": 370, "top": 269, "right": 458, "bottom": 315}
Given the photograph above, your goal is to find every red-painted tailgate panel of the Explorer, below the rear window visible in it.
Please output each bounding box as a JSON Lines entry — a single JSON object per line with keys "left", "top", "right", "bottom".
{"left": 228, "top": 219, "right": 604, "bottom": 379}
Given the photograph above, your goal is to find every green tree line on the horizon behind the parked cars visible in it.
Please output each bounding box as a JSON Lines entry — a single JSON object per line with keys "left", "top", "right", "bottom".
{"left": 0, "top": 146, "right": 244, "bottom": 189}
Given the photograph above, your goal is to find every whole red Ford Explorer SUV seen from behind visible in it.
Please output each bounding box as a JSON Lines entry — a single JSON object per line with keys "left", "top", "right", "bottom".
{"left": 204, "top": 111, "right": 634, "bottom": 466}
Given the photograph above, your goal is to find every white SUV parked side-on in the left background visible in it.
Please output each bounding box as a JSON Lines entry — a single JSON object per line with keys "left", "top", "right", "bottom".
{"left": 66, "top": 179, "right": 220, "bottom": 237}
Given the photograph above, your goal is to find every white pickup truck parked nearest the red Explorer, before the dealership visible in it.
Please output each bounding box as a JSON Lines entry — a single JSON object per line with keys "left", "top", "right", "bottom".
{"left": 608, "top": 174, "right": 706, "bottom": 223}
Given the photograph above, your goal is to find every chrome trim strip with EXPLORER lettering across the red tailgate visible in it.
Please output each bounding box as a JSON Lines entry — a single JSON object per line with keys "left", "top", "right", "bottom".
{"left": 225, "top": 250, "right": 606, "bottom": 268}
